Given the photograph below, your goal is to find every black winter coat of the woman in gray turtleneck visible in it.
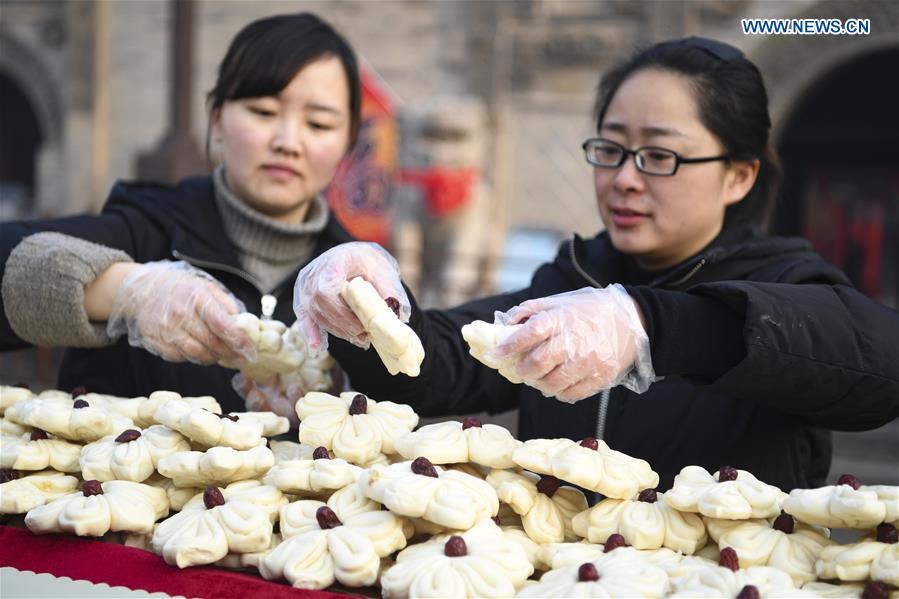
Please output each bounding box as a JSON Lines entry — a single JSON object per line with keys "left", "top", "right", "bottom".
{"left": 0, "top": 177, "right": 352, "bottom": 410}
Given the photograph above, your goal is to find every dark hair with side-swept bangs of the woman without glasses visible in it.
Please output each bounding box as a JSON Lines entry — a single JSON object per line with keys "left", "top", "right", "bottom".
{"left": 206, "top": 12, "right": 362, "bottom": 147}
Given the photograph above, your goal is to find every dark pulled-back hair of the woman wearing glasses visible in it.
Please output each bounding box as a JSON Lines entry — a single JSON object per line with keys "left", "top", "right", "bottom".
{"left": 594, "top": 37, "right": 780, "bottom": 228}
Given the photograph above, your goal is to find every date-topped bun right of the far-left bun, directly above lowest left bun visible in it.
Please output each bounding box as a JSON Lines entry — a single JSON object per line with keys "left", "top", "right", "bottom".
{"left": 80, "top": 424, "right": 190, "bottom": 483}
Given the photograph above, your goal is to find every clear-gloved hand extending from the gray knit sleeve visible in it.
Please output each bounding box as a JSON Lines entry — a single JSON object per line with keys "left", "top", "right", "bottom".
{"left": 106, "top": 260, "right": 256, "bottom": 364}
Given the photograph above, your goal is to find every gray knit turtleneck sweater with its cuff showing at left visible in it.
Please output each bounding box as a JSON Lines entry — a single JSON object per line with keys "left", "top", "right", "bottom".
{"left": 0, "top": 167, "right": 328, "bottom": 347}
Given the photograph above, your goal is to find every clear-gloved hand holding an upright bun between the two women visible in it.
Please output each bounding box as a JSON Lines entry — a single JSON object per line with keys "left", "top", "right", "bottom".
{"left": 293, "top": 241, "right": 412, "bottom": 351}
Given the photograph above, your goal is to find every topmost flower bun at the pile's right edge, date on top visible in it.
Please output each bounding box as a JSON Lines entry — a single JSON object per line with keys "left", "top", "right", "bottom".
{"left": 784, "top": 474, "right": 899, "bottom": 530}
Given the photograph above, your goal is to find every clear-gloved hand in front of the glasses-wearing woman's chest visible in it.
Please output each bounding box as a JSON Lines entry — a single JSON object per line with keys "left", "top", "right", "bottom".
{"left": 488, "top": 284, "right": 656, "bottom": 403}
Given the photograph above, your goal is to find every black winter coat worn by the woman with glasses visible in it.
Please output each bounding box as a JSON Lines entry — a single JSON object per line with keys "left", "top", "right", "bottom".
{"left": 331, "top": 229, "right": 899, "bottom": 490}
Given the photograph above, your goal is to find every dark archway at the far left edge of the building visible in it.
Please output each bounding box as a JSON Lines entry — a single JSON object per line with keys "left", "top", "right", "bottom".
{"left": 0, "top": 72, "right": 43, "bottom": 220}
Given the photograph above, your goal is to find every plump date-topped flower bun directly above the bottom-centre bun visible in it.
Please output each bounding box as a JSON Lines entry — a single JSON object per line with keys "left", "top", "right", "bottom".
{"left": 359, "top": 458, "right": 499, "bottom": 530}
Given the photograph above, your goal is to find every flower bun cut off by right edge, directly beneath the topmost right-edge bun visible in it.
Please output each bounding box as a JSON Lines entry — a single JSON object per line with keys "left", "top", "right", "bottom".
{"left": 815, "top": 523, "right": 899, "bottom": 586}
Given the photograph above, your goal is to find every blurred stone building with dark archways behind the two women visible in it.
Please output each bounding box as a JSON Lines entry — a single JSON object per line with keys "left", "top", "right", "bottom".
{"left": 0, "top": 0, "right": 899, "bottom": 484}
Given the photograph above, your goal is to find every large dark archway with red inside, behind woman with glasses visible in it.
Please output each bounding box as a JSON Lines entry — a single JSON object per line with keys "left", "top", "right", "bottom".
{"left": 772, "top": 47, "right": 899, "bottom": 307}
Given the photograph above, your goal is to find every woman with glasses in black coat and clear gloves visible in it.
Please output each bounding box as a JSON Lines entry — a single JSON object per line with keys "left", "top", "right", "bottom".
{"left": 294, "top": 38, "right": 899, "bottom": 490}
